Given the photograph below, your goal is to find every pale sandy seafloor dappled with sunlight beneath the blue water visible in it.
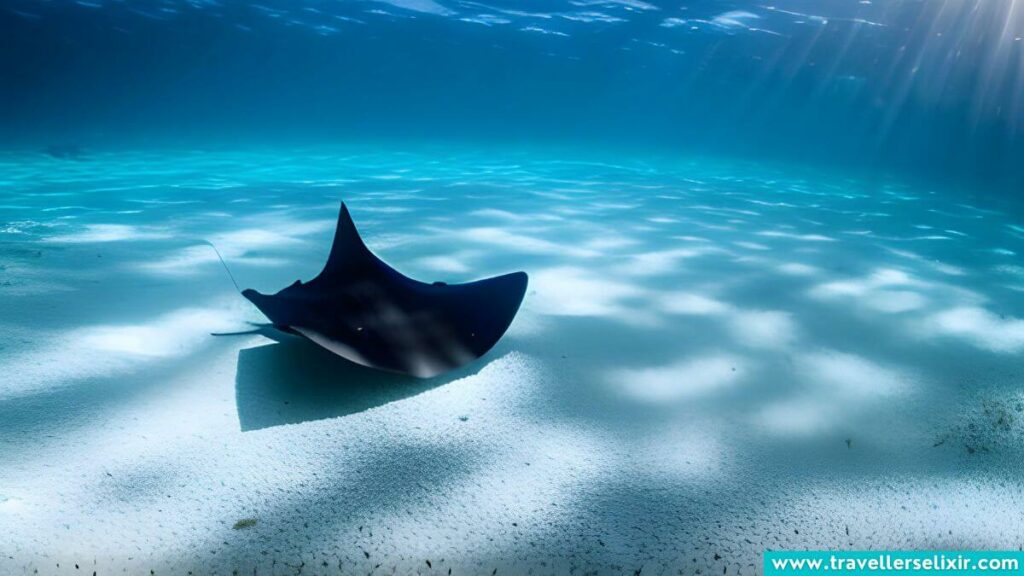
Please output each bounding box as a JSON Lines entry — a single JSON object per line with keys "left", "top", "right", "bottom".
{"left": 0, "top": 148, "right": 1024, "bottom": 574}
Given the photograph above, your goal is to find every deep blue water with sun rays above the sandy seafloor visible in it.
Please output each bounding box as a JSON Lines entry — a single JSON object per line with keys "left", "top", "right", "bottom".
{"left": 0, "top": 0, "right": 1024, "bottom": 194}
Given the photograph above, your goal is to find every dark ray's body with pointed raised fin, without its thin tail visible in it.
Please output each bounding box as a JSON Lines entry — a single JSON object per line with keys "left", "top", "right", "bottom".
{"left": 242, "top": 203, "right": 527, "bottom": 378}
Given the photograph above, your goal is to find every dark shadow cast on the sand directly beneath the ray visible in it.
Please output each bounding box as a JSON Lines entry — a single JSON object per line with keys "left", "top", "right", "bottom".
{"left": 234, "top": 335, "right": 486, "bottom": 431}
